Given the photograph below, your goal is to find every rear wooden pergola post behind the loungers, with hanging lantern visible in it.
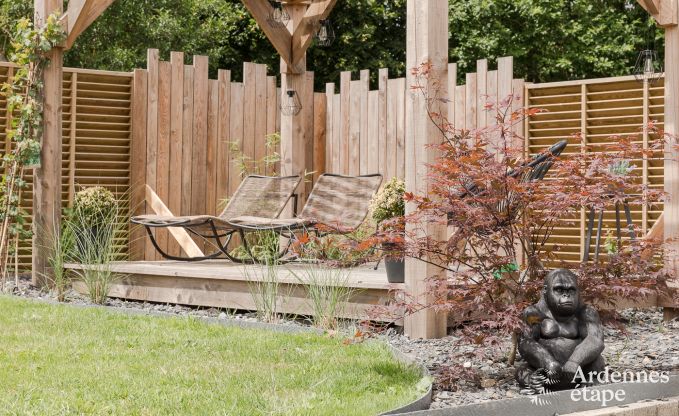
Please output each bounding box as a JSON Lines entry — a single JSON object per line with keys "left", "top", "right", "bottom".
{"left": 280, "top": 3, "right": 306, "bottom": 206}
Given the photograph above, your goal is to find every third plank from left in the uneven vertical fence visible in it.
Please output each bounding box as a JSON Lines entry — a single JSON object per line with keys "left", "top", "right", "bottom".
{"left": 155, "top": 62, "right": 175, "bottom": 252}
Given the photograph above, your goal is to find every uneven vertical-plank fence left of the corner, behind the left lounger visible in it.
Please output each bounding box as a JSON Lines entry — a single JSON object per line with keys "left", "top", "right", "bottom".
{"left": 130, "top": 49, "right": 325, "bottom": 260}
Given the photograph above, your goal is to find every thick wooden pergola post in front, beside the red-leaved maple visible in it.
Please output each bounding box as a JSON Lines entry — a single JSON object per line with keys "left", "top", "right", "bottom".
{"left": 404, "top": 0, "right": 448, "bottom": 338}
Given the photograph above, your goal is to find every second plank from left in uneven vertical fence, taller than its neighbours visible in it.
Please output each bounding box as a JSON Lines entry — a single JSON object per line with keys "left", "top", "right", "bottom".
{"left": 144, "top": 49, "right": 160, "bottom": 260}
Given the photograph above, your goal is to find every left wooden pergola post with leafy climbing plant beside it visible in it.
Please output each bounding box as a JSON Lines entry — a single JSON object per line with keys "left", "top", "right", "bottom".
{"left": 31, "top": 0, "right": 64, "bottom": 286}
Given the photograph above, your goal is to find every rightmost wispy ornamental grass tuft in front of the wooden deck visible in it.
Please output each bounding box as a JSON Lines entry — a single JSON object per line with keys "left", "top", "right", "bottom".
{"left": 290, "top": 263, "right": 357, "bottom": 330}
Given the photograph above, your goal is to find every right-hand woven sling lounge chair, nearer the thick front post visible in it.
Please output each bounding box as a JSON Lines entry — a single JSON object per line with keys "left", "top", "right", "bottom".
{"left": 229, "top": 173, "right": 382, "bottom": 259}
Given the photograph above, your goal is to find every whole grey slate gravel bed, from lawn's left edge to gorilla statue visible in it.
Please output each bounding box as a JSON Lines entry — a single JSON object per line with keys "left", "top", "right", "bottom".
{"left": 6, "top": 278, "right": 679, "bottom": 409}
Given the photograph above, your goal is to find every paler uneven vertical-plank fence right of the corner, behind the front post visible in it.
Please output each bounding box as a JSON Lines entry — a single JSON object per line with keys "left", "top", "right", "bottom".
{"left": 325, "top": 57, "right": 524, "bottom": 179}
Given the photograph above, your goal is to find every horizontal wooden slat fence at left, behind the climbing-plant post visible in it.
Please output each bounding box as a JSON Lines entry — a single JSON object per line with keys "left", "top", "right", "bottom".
{"left": 0, "top": 62, "right": 132, "bottom": 269}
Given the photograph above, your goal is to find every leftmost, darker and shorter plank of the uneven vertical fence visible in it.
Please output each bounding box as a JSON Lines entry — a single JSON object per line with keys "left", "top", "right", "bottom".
{"left": 129, "top": 69, "right": 148, "bottom": 260}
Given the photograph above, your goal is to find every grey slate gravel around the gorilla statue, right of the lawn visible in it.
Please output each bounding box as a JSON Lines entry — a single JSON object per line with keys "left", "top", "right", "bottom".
{"left": 387, "top": 309, "right": 679, "bottom": 409}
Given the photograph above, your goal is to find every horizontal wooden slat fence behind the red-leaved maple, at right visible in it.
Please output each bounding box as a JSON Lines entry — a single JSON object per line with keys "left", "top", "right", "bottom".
{"left": 525, "top": 77, "right": 664, "bottom": 262}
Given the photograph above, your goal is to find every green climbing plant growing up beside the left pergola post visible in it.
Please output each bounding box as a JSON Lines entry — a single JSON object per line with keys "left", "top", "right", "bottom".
{"left": 0, "top": 14, "right": 65, "bottom": 288}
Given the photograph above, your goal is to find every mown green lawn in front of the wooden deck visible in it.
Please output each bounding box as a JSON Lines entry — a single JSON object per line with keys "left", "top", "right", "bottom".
{"left": 0, "top": 296, "right": 420, "bottom": 415}
